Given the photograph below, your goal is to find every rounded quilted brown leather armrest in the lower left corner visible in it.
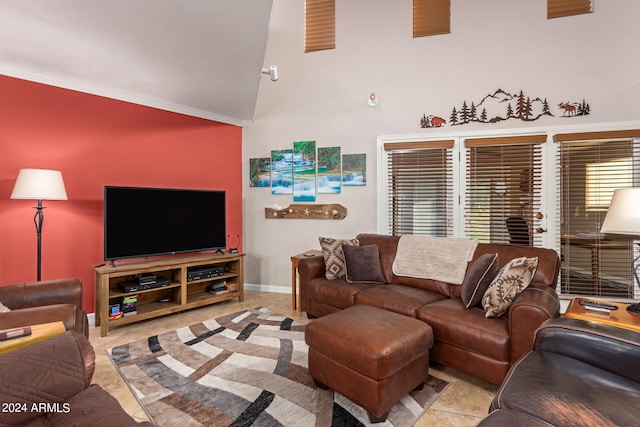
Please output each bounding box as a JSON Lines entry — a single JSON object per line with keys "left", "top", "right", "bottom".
{"left": 0, "top": 332, "right": 95, "bottom": 425}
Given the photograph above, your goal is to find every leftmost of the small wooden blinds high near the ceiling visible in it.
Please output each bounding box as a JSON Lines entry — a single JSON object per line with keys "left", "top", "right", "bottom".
{"left": 304, "top": 0, "right": 336, "bottom": 53}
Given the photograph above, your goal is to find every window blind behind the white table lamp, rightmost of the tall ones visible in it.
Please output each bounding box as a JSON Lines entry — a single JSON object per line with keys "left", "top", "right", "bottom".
{"left": 554, "top": 131, "right": 640, "bottom": 298}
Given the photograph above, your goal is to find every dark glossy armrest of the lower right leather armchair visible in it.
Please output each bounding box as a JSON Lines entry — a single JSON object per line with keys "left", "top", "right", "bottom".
{"left": 534, "top": 318, "right": 640, "bottom": 382}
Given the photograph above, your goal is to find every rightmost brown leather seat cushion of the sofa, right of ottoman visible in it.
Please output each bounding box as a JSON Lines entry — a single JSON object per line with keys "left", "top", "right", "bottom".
{"left": 416, "top": 298, "right": 509, "bottom": 363}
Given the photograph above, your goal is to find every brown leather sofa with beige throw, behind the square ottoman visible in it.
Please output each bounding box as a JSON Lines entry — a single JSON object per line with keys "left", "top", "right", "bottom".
{"left": 298, "top": 234, "right": 560, "bottom": 384}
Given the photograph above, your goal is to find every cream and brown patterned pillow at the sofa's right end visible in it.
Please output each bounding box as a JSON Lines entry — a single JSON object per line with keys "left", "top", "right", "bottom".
{"left": 482, "top": 257, "right": 538, "bottom": 317}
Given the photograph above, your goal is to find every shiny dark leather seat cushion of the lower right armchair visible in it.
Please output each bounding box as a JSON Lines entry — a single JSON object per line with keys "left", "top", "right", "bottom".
{"left": 491, "top": 351, "right": 640, "bottom": 427}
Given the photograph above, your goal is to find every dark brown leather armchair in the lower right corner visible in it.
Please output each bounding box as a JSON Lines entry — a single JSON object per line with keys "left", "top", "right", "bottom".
{"left": 478, "top": 318, "right": 640, "bottom": 427}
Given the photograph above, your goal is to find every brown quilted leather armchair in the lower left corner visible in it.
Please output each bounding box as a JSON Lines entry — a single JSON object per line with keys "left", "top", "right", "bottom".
{"left": 0, "top": 332, "right": 152, "bottom": 427}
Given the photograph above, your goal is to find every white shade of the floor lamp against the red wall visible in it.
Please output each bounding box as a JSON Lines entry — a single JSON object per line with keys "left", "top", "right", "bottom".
{"left": 11, "top": 169, "right": 67, "bottom": 200}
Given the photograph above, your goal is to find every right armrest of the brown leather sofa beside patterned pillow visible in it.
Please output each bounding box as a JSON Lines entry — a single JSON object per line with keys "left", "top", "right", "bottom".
{"left": 509, "top": 284, "right": 560, "bottom": 363}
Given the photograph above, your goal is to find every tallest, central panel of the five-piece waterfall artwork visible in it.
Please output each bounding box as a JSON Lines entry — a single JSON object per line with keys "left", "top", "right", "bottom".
{"left": 292, "top": 141, "right": 316, "bottom": 202}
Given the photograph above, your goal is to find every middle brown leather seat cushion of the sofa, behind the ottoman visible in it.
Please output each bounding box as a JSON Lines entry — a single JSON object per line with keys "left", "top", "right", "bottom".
{"left": 355, "top": 285, "right": 447, "bottom": 317}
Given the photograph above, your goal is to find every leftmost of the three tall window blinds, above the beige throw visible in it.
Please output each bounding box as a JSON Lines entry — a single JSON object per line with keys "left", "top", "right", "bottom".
{"left": 384, "top": 140, "right": 454, "bottom": 237}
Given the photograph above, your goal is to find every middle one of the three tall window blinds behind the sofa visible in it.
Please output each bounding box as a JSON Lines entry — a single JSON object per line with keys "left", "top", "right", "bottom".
{"left": 465, "top": 134, "right": 547, "bottom": 246}
